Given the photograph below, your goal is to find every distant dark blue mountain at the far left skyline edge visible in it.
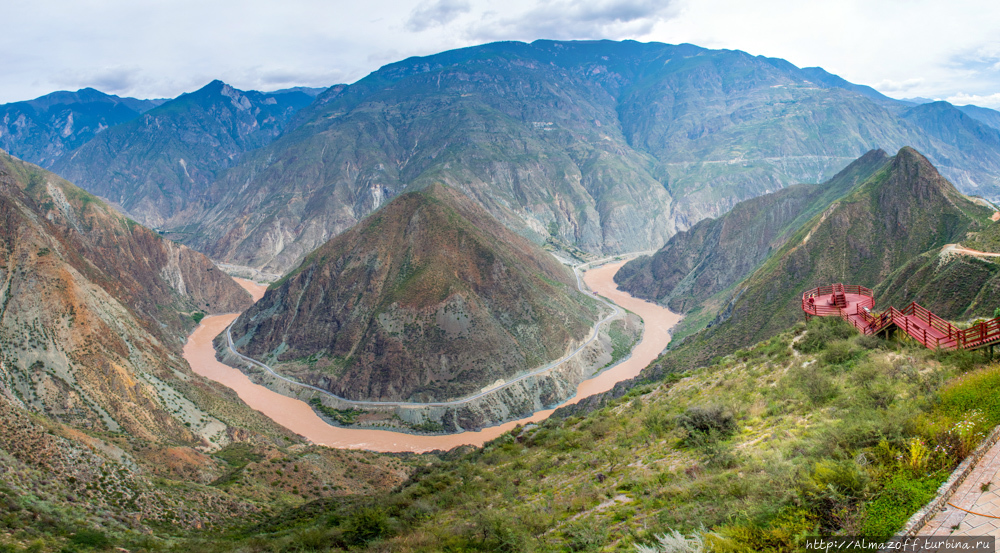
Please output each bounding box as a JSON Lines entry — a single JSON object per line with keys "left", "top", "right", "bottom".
{"left": 0, "top": 88, "right": 163, "bottom": 167}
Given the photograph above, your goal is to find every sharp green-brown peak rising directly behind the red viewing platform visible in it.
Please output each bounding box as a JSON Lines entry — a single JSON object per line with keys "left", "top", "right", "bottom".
{"left": 667, "top": 147, "right": 992, "bottom": 365}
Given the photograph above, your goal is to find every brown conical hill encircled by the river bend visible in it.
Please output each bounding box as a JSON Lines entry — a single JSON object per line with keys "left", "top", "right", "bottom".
{"left": 232, "top": 185, "right": 599, "bottom": 401}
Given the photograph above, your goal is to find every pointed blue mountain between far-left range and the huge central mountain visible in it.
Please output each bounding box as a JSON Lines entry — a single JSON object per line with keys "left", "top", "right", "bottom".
{"left": 53, "top": 81, "right": 313, "bottom": 227}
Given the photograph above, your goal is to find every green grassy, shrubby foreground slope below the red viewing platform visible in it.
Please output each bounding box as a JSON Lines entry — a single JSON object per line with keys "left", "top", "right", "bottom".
{"left": 129, "top": 319, "right": 1000, "bottom": 551}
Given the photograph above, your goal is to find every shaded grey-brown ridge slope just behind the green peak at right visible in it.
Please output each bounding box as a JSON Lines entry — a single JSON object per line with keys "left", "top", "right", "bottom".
{"left": 615, "top": 150, "right": 889, "bottom": 313}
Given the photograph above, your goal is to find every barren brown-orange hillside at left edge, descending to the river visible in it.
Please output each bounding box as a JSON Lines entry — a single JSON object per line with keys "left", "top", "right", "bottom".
{"left": 0, "top": 149, "right": 408, "bottom": 551}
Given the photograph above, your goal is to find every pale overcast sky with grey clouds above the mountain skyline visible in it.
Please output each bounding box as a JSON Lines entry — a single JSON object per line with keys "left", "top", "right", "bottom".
{"left": 0, "top": 0, "right": 1000, "bottom": 107}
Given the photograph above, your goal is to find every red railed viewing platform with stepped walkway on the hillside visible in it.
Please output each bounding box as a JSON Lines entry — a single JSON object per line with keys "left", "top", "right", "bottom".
{"left": 802, "top": 284, "right": 1000, "bottom": 350}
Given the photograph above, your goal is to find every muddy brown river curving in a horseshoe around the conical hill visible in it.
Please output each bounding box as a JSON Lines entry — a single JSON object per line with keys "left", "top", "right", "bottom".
{"left": 184, "top": 261, "right": 681, "bottom": 453}
